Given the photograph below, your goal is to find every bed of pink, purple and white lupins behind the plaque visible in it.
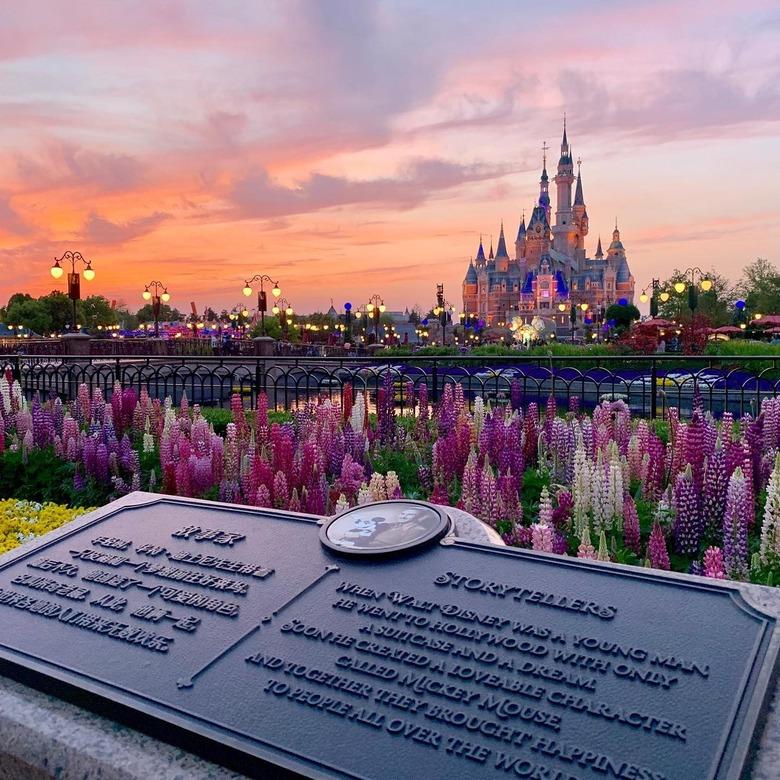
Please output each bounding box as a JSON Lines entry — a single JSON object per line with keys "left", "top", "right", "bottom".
{"left": 0, "top": 374, "right": 780, "bottom": 584}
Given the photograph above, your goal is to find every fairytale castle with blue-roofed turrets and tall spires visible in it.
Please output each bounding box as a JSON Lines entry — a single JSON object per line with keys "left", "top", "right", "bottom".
{"left": 463, "top": 120, "right": 634, "bottom": 331}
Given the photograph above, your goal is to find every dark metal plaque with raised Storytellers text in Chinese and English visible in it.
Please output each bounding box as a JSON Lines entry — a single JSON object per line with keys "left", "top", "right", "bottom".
{"left": 0, "top": 494, "right": 776, "bottom": 780}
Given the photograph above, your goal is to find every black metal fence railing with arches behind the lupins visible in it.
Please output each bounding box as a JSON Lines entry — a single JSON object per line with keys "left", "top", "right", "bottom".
{"left": 0, "top": 354, "right": 780, "bottom": 418}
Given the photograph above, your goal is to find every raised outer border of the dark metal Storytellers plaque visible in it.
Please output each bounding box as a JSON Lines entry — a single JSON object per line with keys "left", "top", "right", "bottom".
{"left": 0, "top": 492, "right": 780, "bottom": 780}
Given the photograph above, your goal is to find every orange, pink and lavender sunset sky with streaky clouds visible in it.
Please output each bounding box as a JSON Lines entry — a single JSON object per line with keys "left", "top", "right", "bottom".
{"left": 0, "top": 0, "right": 780, "bottom": 312}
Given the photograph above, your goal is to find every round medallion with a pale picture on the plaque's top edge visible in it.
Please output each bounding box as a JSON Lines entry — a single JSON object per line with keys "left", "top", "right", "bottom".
{"left": 320, "top": 500, "right": 450, "bottom": 555}
